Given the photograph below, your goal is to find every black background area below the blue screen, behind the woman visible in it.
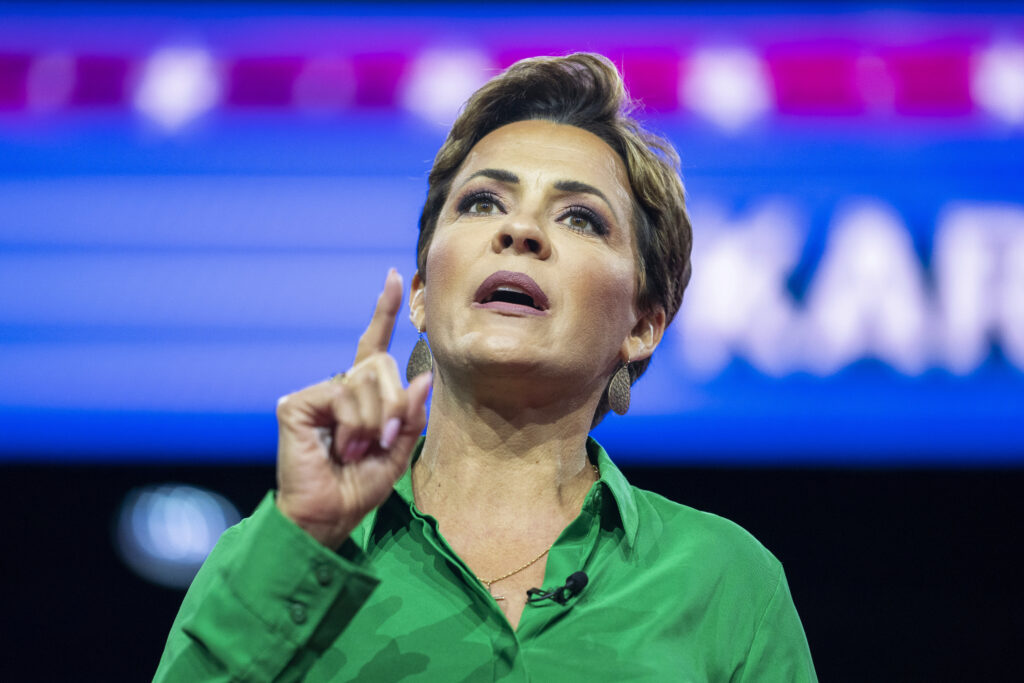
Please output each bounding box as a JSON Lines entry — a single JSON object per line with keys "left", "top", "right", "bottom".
{"left": 8, "top": 465, "right": 1024, "bottom": 681}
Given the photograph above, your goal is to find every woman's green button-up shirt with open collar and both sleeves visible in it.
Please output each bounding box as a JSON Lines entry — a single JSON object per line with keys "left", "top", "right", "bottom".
{"left": 156, "top": 439, "right": 816, "bottom": 683}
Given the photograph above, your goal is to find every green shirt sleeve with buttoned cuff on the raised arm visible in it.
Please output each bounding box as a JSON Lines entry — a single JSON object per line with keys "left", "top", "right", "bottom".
{"left": 154, "top": 493, "right": 378, "bottom": 682}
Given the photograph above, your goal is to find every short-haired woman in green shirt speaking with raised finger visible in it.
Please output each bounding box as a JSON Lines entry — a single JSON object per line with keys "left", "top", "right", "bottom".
{"left": 157, "top": 54, "right": 815, "bottom": 681}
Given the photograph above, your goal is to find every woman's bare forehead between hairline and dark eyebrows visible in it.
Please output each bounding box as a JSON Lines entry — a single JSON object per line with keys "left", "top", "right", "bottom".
{"left": 456, "top": 121, "right": 632, "bottom": 205}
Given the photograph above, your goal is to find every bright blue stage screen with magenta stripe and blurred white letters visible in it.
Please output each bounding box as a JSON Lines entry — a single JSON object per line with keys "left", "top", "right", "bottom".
{"left": 0, "top": 3, "right": 1024, "bottom": 466}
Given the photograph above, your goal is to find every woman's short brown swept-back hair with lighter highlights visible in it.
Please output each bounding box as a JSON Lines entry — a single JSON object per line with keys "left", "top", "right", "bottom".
{"left": 417, "top": 52, "right": 692, "bottom": 426}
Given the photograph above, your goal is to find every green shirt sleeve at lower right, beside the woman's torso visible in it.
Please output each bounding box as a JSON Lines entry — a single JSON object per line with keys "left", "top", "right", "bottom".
{"left": 733, "top": 566, "right": 818, "bottom": 683}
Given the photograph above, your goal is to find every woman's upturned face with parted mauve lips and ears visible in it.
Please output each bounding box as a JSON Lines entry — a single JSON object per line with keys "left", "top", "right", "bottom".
{"left": 412, "top": 121, "right": 649, "bottom": 393}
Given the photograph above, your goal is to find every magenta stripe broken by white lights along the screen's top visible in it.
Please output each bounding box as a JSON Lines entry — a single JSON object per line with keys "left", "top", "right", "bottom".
{"left": 0, "top": 32, "right": 1007, "bottom": 118}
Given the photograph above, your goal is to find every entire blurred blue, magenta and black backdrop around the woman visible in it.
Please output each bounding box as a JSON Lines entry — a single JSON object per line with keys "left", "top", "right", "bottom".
{"left": 0, "top": 2, "right": 1024, "bottom": 681}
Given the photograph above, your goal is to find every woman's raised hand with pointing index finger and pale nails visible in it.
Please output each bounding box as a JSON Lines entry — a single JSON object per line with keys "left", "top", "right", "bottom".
{"left": 278, "top": 269, "right": 431, "bottom": 549}
